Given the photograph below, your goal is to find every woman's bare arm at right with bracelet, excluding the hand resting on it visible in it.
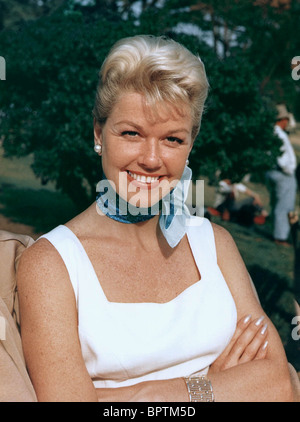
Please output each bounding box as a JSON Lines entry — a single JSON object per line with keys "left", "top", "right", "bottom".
{"left": 206, "top": 225, "right": 293, "bottom": 401}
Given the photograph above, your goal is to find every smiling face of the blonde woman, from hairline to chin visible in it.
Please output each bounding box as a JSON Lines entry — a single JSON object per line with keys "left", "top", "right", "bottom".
{"left": 94, "top": 93, "right": 193, "bottom": 208}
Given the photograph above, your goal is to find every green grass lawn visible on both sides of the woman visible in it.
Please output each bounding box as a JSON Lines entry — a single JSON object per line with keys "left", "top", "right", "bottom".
{"left": 0, "top": 143, "right": 300, "bottom": 370}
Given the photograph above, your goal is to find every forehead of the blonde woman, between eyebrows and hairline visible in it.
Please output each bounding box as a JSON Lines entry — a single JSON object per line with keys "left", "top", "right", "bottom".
{"left": 109, "top": 92, "right": 192, "bottom": 127}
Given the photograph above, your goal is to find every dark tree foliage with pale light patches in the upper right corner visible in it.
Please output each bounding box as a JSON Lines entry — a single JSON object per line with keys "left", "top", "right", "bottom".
{"left": 167, "top": 0, "right": 300, "bottom": 118}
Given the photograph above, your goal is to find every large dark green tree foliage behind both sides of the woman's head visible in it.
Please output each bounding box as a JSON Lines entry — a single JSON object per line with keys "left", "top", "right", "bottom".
{"left": 0, "top": 0, "right": 290, "bottom": 208}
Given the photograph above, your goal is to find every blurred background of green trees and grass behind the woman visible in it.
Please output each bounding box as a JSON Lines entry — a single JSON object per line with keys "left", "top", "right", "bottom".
{"left": 0, "top": 0, "right": 300, "bottom": 371}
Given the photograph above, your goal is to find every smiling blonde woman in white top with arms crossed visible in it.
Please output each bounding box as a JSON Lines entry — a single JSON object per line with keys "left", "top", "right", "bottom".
{"left": 18, "top": 36, "right": 292, "bottom": 402}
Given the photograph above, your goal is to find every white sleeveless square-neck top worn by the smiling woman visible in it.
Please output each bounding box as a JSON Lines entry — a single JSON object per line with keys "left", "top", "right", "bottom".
{"left": 42, "top": 217, "right": 237, "bottom": 388}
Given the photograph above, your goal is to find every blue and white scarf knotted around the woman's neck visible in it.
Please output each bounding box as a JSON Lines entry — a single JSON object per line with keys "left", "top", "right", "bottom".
{"left": 96, "top": 166, "right": 192, "bottom": 248}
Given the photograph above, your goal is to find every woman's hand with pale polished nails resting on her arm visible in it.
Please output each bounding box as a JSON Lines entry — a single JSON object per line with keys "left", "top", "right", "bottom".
{"left": 209, "top": 315, "right": 268, "bottom": 373}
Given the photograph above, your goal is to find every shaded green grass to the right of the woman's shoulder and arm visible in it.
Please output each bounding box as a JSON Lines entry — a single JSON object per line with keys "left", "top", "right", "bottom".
{"left": 200, "top": 175, "right": 300, "bottom": 356}
